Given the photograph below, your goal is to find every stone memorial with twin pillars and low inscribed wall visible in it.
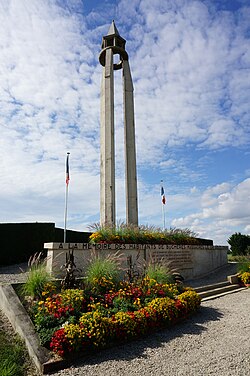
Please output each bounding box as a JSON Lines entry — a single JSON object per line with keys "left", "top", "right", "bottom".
{"left": 44, "top": 21, "right": 227, "bottom": 278}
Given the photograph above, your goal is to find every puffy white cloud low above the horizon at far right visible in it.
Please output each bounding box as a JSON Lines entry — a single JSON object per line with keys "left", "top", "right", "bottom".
{"left": 172, "top": 178, "right": 250, "bottom": 243}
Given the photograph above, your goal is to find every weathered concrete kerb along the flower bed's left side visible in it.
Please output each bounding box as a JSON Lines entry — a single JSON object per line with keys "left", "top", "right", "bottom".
{"left": 0, "top": 284, "right": 67, "bottom": 374}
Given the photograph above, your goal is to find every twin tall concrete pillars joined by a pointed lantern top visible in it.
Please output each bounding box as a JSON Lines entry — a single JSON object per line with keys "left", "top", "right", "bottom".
{"left": 99, "top": 21, "right": 138, "bottom": 226}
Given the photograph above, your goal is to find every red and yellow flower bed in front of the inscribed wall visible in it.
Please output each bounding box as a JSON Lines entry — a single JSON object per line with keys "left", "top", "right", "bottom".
{"left": 30, "top": 278, "right": 201, "bottom": 357}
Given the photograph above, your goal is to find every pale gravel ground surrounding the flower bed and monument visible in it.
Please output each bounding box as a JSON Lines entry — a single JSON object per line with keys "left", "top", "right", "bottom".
{"left": 0, "top": 265, "right": 250, "bottom": 376}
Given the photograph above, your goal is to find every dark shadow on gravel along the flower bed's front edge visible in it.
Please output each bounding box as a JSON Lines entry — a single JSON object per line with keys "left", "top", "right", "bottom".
{"left": 68, "top": 307, "right": 223, "bottom": 367}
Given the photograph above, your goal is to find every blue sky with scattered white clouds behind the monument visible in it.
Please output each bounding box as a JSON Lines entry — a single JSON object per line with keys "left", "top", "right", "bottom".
{"left": 0, "top": 0, "right": 250, "bottom": 245}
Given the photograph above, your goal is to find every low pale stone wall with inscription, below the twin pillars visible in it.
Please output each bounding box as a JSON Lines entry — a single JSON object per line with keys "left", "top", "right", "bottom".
{"left": 44, "top": 243, "right": 228, "bottom": 279}
